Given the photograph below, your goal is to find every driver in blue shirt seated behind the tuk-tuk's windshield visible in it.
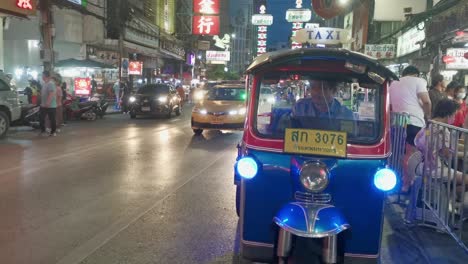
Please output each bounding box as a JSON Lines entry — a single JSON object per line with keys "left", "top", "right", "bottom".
{"left": 292, "top": 80, "right": 354, "bottom": 120}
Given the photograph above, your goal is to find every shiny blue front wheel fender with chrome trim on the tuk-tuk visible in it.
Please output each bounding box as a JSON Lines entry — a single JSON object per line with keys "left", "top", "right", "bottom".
{"left": 274, "top": 202, "right": 350, "bottom": 238}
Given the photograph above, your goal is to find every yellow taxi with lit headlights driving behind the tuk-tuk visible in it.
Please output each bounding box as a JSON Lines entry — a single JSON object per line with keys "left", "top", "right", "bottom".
{"left": 192, "top": 84, "right": 246, "bottom": 135}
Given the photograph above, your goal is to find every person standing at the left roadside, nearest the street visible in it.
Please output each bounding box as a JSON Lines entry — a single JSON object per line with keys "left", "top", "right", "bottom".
{"left": 39, "top": 71, "right": 57, "bottom": 136}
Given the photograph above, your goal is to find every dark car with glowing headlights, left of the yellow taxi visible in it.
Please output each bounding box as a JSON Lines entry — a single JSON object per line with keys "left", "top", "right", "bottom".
{"left": 128, "top": 84, "right": 182, "bottom": 118}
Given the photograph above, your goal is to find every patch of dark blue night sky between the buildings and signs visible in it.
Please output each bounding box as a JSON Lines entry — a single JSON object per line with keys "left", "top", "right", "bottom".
{"left": 267, "top": 0, "right": 311, "bottom": 46}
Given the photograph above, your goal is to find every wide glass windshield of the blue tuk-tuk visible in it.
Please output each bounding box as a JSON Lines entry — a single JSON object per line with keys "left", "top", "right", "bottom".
{"left": 256, "top": 73, "right": 382, "bottom": 144}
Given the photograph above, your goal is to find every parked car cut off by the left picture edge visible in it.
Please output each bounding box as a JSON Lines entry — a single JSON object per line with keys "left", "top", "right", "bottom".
{"left": 0, "top": 73, "right": 21, "bottom": 138}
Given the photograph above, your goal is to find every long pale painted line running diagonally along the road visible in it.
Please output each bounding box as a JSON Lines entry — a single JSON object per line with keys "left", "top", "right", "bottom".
{"left": 57, "top": 146, "right": 231, "bottom": 264}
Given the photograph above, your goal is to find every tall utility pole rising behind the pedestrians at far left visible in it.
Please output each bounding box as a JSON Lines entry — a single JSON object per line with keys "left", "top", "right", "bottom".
{"left": 39, "top": 0, "right": 54, "bottom": 71}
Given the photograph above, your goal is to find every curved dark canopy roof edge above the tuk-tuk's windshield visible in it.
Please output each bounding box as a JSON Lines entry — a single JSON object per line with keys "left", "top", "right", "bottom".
{"left": 246, "top": 48, "right": 398, "bottom": 80}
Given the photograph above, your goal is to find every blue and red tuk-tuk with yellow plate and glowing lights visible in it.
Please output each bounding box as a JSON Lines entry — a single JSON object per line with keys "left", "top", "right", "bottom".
{"left": 234, "top": 48, "right": 399, "bottom": 263}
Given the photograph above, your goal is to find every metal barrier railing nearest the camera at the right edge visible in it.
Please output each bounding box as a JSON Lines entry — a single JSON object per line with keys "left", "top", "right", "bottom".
{"left": 405, "top": 121, "right": 468, "bottom": 252}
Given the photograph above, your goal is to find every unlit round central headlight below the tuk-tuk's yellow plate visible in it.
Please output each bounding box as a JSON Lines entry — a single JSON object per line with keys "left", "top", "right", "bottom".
{"left": 299, "top": 162, "right": 329, "bottom": 192}
